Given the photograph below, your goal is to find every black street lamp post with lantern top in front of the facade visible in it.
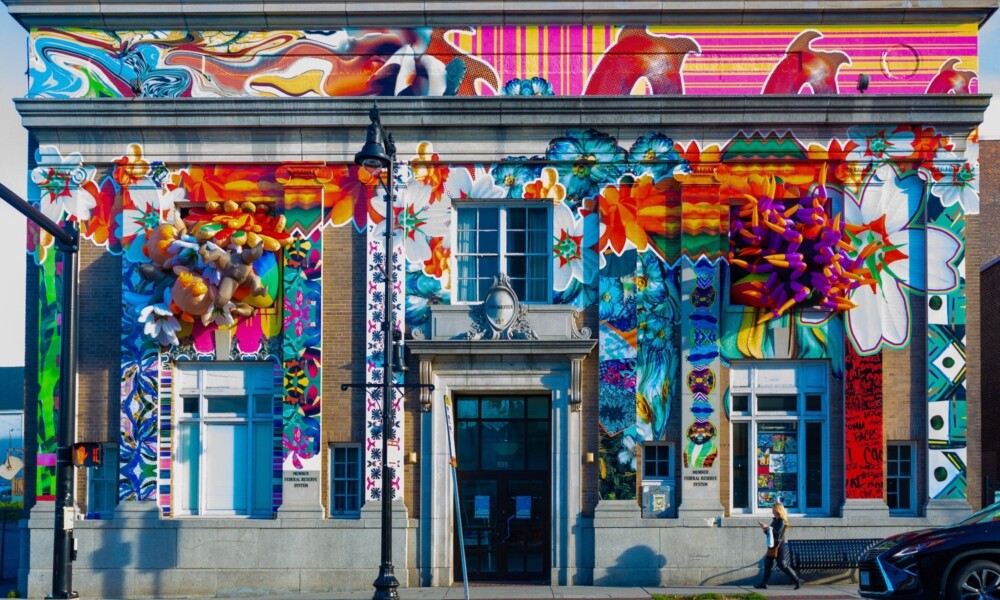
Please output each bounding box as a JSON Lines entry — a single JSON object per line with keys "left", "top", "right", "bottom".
{"left": 354, "top": 104, "right": 399, "bottom": 600}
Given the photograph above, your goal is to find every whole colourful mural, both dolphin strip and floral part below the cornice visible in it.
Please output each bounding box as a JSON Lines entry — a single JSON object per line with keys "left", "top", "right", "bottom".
{"left": 29, "top": 14, "right": 978, "bottom": 504}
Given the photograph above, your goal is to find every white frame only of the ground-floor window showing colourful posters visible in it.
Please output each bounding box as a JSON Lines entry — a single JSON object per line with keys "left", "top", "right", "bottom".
{"left": 729, "top": 360, "right": 831, "bottom": 516}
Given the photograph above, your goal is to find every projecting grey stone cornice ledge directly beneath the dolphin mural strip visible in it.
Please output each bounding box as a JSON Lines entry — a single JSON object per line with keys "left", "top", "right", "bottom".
{"left": 15, "top": 94, "right": 991, "bottom": 132}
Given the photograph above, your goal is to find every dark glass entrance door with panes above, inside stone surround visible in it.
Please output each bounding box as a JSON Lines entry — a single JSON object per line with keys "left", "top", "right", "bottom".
{"left": 455, "top": 396, "right": 551, "bottom": 582}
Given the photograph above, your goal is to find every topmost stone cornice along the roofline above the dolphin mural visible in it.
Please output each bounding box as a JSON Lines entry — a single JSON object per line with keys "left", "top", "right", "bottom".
{"left": 3, "top": 0, "right": 997, "bottom": 31}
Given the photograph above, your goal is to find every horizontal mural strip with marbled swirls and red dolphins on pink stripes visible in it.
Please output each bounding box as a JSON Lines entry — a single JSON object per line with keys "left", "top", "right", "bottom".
{"left": 28, "top": 23, "right": 979, "bottom": 98}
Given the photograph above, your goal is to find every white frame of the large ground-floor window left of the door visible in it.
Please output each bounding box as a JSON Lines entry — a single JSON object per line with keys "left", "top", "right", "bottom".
{"left": 171, "top": 361, "right": 275, "bottom": 518}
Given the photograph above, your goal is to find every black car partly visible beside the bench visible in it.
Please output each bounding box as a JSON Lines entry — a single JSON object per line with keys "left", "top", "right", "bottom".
{"left": 858, "top": 502, "right": 1000, "bottom": 600}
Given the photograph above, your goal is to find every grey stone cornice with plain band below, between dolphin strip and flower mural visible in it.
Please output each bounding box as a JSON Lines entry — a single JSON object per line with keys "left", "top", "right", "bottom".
{"left": 15, "top": 94, "right": 990, "bottom": 162}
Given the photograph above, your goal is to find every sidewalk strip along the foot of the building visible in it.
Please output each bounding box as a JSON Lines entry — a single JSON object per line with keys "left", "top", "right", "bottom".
{"left": 267, "top": 584, "right": 860, "bottom": 600}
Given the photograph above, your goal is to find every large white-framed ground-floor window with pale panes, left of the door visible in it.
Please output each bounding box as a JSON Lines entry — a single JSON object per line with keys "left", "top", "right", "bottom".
{"left": 173, "top": 363, "right": 275, "bottom": 517}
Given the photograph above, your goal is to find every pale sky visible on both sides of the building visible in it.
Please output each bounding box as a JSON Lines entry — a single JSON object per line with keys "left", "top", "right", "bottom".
{"left": 0, "top": 6, "right": 1000, "bottom": 368}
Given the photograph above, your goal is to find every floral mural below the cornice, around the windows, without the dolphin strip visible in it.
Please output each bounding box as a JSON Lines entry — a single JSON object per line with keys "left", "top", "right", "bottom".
{"left": 34, "top": 126, "right": 978, "bottom": 502}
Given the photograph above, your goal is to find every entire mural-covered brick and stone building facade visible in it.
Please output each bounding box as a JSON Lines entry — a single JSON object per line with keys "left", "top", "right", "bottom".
{"left": 5, "top": 0, "right": 996, "bottom": 597}
